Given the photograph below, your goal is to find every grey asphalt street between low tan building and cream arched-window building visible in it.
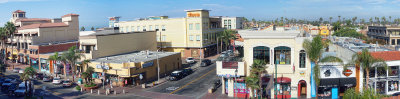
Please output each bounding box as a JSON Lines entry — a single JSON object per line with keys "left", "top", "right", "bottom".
{"left": 147, "top": 63, "right": 218, "bottom": 98}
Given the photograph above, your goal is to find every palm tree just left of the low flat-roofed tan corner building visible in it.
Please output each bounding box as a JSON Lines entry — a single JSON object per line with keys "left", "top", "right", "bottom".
{"left": 63, "top": 46, "right": 83, "bottom": 82}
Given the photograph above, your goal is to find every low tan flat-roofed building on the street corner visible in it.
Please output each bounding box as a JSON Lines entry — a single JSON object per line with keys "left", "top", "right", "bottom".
{"left": 88, "top": 51, "right": 182, "bottom": 85}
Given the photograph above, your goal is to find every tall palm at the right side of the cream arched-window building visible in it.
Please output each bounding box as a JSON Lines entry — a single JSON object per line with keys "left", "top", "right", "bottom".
{"left": 303, "top": 36, "right": 343, "bottom": 95}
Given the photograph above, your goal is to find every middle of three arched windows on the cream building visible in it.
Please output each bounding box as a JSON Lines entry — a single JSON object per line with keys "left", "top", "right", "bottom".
{"left": 274, "top": 46, "right": 291, "bottom": 64}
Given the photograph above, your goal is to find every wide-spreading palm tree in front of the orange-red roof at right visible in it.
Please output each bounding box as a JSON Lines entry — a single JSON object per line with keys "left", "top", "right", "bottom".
{"left": 345, "top": 49, "right": 387, "bottom": 88}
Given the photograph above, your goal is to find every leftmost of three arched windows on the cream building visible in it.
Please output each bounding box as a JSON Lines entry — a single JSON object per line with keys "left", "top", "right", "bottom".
{"left": 253, "top": 46, "right": 270, "bottom": 64}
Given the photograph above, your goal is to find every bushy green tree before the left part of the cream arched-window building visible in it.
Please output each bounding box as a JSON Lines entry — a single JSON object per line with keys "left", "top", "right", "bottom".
{"left": 246, "top": 59, "right": 267, "bottom": 97}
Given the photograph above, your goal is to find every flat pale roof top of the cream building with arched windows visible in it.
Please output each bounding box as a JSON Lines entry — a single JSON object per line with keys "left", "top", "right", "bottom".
{"left": 239, "top": 30, "right": 300, "bottom": 39}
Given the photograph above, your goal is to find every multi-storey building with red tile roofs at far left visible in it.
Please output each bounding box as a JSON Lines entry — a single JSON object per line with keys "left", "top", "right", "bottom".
{"left": 5, "top": 10, "right": 79, "bottom": 72}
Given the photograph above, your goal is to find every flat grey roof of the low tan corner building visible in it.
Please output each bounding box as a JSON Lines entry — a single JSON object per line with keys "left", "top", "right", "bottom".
{"left": 91, "top": 51, "right": 180, "bottom": 63}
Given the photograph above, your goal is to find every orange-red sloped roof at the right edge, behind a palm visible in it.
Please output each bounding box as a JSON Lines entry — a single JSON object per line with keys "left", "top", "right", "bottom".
{"left": 371, "top": 51, "right": 400, "bottom": 61}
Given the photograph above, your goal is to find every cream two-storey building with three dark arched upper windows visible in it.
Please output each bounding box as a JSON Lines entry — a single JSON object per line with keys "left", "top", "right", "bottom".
{"left": 217, "top": 30, "right": 312, "bottom": 98}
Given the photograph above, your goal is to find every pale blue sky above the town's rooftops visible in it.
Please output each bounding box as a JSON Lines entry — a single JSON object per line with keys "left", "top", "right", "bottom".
{"left": 0, "top": 0, "right": 400, "bottom": 27}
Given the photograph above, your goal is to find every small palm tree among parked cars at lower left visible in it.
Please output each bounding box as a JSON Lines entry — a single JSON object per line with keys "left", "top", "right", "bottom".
{"left": 20, "top": 67, "right": 36, "bottom": 96}
